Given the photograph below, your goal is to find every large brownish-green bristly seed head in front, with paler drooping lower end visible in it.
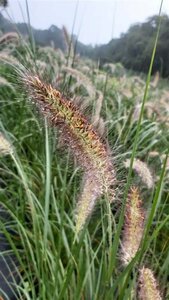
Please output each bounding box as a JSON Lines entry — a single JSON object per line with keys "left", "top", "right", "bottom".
{"left": 22, "top": 74, "right": 115, "bottom": 231}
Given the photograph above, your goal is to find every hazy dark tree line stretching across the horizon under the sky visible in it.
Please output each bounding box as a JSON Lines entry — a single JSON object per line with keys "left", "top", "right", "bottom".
{"left": 0, "top": 9, "right": 169, "bottom": 77}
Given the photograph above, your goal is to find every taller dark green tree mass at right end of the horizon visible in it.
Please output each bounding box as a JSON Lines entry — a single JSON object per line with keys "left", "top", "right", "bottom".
{"left": 94, "top": 15, "right": 169, "bottom": 77}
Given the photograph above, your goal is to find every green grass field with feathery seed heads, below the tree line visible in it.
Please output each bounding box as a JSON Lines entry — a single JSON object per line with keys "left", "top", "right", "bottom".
{"left": 0, "top": 24, "right": 169, "bottom": 300}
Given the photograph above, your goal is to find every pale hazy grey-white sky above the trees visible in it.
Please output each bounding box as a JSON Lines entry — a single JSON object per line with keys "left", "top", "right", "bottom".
{"left": 3, "top": 0, "right": 169, "bottom": 45}
